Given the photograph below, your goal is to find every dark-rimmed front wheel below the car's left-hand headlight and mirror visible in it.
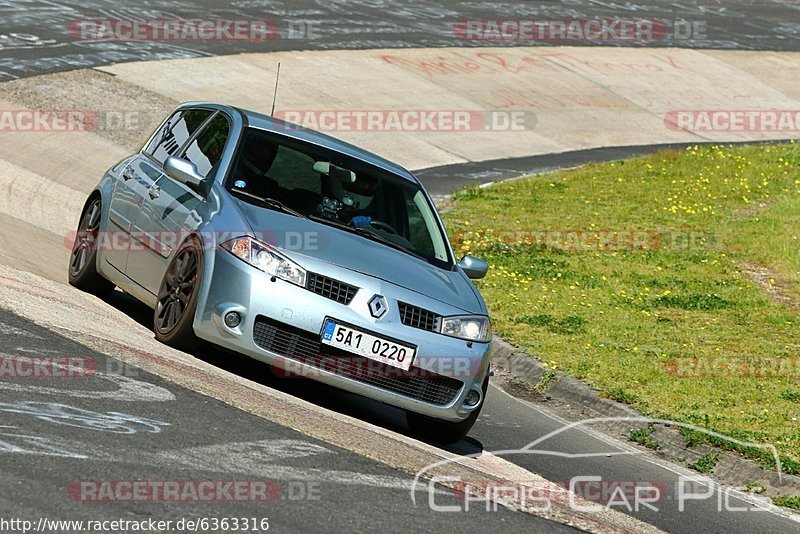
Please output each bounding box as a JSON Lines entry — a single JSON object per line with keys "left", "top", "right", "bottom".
{"left": 153, "top": 237, "right": 203, "bottom": 350}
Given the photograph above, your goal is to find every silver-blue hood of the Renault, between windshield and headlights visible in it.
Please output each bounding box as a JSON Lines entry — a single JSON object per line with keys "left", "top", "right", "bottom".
{"left": 236, "top": 200, "right": 485, "bottom": 314}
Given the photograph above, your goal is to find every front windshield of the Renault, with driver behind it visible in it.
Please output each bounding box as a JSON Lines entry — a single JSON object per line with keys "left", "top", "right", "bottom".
{"left": 227, "top": 128, "right": 450, "bottom": 268}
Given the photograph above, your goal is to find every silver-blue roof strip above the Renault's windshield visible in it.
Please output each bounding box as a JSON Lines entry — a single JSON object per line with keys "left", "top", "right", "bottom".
{"left": 225, "top": 104, "right": 419, "bottom": 184}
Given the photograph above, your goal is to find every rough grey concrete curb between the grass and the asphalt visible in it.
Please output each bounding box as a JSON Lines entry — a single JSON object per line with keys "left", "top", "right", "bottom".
{"left": 492, "top": 336, "right": 800, "bottom": 502}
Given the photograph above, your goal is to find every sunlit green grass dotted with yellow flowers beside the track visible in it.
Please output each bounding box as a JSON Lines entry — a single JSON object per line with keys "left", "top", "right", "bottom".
{"left": 445, "top": 144, "right": 800, "bottom": 473}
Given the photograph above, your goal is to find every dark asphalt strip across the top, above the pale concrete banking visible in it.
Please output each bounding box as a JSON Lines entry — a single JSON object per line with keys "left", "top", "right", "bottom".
{"left": 0, "top": 0, "right": 800, "bottom": 81}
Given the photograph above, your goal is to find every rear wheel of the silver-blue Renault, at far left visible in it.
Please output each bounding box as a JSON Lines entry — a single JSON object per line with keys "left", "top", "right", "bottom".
{"left": 67, "top": 195, "right": 114, "bottom": 296}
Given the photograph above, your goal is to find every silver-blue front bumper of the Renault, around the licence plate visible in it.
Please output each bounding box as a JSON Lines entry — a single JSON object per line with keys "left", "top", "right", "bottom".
{"left": 194, "top": 249, "right": 491, "bottom": 422}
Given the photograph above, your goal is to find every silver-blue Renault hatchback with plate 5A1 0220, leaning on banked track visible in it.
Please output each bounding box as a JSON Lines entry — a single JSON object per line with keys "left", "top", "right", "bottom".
{"left": 69, "top": 103, "right": 491, "bottom": 443}
